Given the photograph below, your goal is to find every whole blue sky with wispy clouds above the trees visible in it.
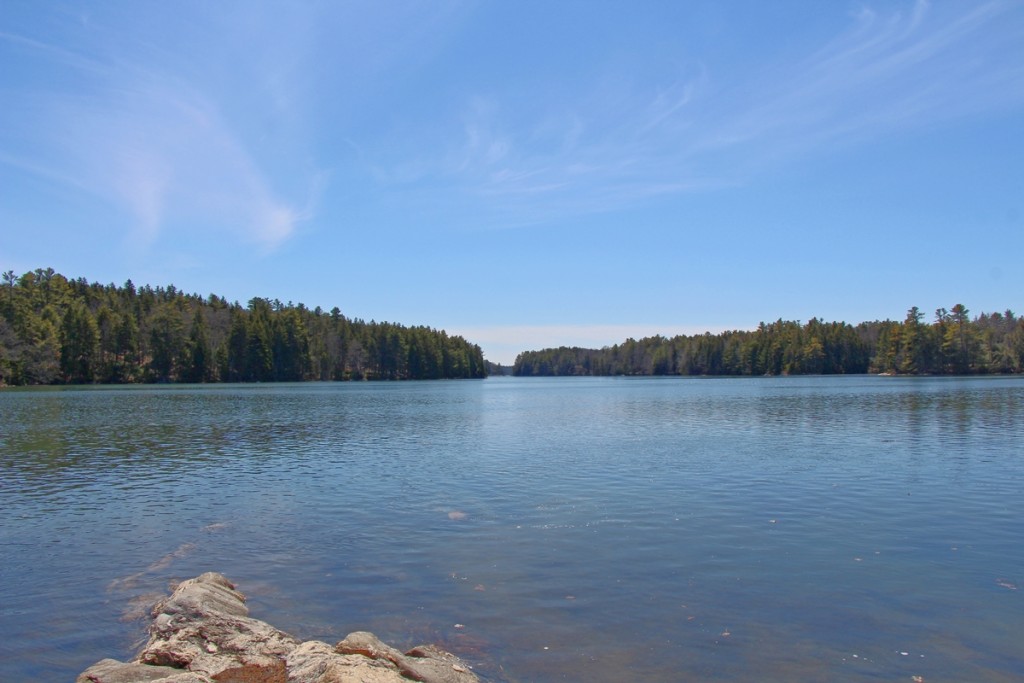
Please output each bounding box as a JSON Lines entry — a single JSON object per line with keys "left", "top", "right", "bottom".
{"left": 0, "top": 0, "right": 1024, "bottom": 364}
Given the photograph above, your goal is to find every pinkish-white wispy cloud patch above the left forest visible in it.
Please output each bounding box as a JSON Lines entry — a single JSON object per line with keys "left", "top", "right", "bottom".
{"left": 0, "top": 18, "right": 309, "bottom": 251}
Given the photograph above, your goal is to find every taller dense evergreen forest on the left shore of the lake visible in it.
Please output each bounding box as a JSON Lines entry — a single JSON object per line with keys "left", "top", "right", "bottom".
{"left": 0, "top": 268, "right": 486, "bottom": 386}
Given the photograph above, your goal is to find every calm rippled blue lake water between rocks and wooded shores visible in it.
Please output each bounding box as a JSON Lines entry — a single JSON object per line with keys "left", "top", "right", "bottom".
{"left": 0, "top": 377, "right": 1024, "bottom": 682}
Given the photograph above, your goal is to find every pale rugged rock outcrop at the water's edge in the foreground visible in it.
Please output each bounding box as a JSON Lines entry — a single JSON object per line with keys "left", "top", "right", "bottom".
{"left": 77, "top": 572, "right": 479, "bottom": 683}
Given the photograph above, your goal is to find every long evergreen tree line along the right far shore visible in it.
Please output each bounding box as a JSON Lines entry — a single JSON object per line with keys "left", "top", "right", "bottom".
{"left": 513, "top": 304, "right": 1024, "bottom": 377}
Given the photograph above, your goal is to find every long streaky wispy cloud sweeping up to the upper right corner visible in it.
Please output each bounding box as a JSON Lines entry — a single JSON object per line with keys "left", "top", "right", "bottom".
{"left": 384, "top": 0, "right": 1024, "bottom": 226}
